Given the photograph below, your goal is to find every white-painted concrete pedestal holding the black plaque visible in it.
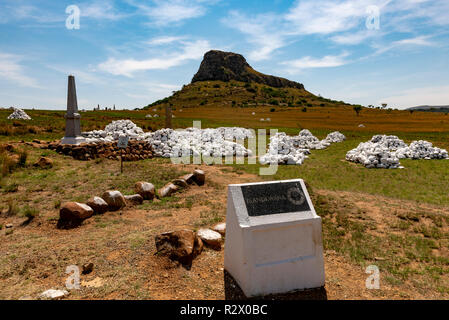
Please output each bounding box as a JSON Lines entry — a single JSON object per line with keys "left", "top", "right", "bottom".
{"left": 224, "top": 179, "right": 325, "bottom": 297}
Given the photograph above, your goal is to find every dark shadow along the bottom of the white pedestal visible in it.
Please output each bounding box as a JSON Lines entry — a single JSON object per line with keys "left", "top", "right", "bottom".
{"left": 224, "top": 270, "right": 327, "bottom": 300}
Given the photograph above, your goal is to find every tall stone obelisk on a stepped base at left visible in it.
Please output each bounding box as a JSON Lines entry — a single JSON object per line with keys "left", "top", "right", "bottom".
{"left": 61, "top": 75, "right": 85, "bottom": 144}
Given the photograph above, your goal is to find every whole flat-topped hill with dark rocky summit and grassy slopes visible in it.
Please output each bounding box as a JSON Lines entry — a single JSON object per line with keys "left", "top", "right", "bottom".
{"left": 143, "top": 50, "right": 347, "bottom": 111}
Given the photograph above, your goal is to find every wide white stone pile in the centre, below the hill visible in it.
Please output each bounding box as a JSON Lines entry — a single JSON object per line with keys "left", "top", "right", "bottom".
{"left": 147, "top": 127, "right": 253, "bottom": 158}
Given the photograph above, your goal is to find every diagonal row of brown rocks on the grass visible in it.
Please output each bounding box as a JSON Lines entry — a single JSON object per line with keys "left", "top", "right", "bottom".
{"left": 57, "top": 170, "right": 206, "bottom": 229}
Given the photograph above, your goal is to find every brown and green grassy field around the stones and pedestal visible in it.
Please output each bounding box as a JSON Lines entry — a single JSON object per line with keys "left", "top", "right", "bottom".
{"left": 0, "top": 103, "right": 449, "bottom": 299}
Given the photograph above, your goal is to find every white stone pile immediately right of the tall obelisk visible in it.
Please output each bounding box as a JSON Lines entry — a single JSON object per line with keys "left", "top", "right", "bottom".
{"left": 82, "top": 120, "right": 148, "bottom": 143}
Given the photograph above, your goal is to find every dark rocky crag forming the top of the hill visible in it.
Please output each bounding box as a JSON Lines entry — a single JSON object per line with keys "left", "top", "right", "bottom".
{"left": 192, "top": 50, "right": 304, "bottom": 89}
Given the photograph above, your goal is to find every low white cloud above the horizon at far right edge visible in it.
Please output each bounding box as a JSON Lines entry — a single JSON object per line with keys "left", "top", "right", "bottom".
{"left": 378, "top": 85, "right": 449, "bottom": 108}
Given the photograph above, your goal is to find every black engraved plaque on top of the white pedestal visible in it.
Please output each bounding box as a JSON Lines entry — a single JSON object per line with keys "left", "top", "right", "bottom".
{"left": 241, "top": 181, "right": 310, "bottom": 217}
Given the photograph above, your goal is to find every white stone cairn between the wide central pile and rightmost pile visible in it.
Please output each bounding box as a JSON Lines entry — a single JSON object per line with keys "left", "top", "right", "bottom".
{"left": 259, "top": 129, "right": 346, "bottom": 165}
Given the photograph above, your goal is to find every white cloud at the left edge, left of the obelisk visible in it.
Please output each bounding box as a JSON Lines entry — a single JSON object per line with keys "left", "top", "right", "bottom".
{"left": 0, "top": 52, "right": 40, "bottom": 88}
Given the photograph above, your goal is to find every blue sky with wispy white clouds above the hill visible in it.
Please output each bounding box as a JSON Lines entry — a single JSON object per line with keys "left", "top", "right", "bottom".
{"left": 0, "top": 0, "right": 449, "bottom": 109}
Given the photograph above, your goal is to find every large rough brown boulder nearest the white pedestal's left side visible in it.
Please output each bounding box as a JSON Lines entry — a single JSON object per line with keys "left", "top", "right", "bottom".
{"left": 155, "top": 229, "right": 203, "bottom": 268}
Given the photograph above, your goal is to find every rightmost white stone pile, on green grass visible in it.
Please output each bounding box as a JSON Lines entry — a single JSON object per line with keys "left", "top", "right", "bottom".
{"left": 346, "top": 135, "right": 449, "bottom": 169}
